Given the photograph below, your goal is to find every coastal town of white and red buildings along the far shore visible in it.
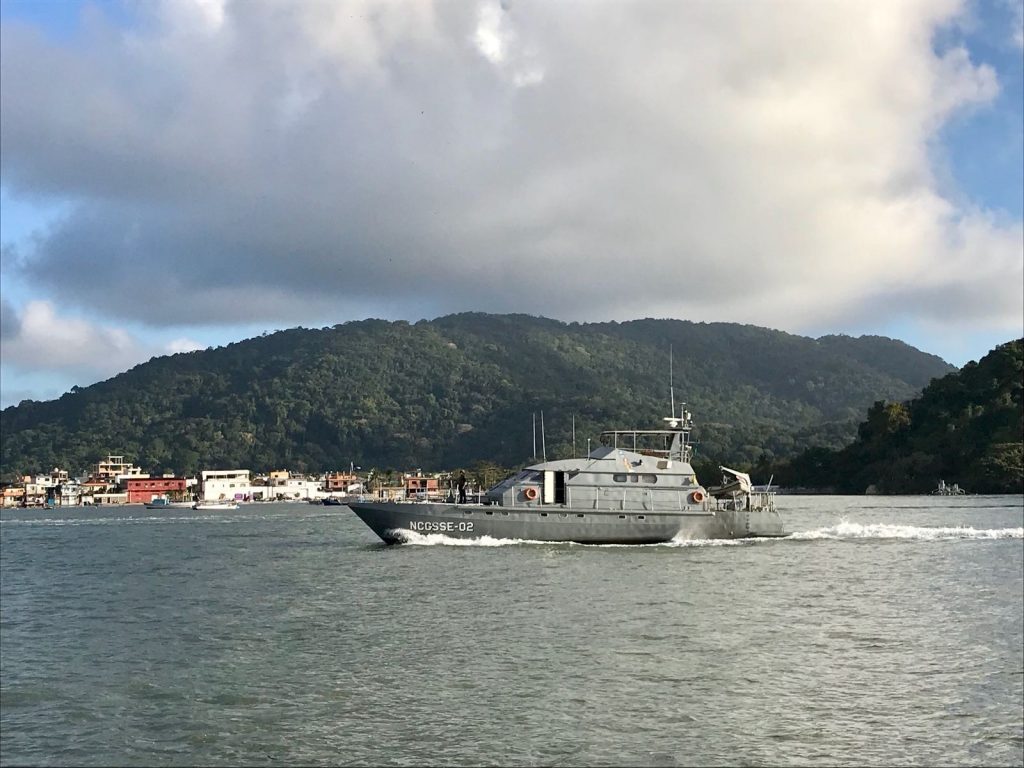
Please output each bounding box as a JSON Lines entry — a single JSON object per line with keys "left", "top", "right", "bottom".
{"left": 0, "top": 455, "right": 471, "bottom": 508}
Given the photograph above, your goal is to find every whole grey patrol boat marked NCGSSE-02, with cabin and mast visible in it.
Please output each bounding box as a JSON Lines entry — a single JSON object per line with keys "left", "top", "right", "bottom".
{"left": 347, "top": 407, "right": 787, "bottom": 544}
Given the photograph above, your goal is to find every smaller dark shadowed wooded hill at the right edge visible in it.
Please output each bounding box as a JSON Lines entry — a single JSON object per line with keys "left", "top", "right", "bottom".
{"left": 779, "top": 340, "right": 1024, "bottom": 494}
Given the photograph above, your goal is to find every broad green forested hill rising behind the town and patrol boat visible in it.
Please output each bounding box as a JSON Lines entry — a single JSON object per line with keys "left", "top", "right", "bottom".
{"left": 0, "top": 313, "right": 954, "bottom": 475}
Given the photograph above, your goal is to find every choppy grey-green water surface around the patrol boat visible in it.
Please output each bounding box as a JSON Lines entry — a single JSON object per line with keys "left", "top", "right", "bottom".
{"left": 0, "top": 497, "right": 1024, "bottom": 766}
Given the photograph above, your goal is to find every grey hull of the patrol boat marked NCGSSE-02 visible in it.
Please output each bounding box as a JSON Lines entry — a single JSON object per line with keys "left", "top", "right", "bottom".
{"left": 348, "top": 502, "right": 786, "bottom": 545}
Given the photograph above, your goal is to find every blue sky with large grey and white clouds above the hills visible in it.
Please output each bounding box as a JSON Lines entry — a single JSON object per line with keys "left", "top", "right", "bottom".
{"left": 0, "top": 0, "right": 1024, "bottom": 407}
